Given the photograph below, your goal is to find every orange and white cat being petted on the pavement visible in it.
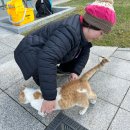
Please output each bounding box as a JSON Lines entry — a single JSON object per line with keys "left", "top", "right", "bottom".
{"left": 19, "top": 58, "right": 109, "bottom": 116}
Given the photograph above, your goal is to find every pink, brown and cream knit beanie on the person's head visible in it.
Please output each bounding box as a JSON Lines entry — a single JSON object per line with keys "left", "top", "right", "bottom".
{"left": 83, "top": 0, "right": 116, "bottom": 33}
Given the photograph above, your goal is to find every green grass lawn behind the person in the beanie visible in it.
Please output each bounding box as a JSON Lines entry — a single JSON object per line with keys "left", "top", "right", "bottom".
{"left": 24, "top": 0, "right": 130, "bottom": 48}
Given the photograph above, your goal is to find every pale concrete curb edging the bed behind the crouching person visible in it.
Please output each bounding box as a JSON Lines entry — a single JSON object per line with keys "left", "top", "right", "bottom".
{"left": 0, "top": 6, "right": 76, "bottom": 34}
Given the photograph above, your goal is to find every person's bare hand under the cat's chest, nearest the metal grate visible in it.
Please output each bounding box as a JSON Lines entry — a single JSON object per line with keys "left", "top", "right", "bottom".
{"left": 41, "top": 100, "right": 56, "bottom": 114}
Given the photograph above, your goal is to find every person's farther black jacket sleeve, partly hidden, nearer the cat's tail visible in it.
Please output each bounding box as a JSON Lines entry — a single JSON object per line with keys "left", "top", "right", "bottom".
{"left": 73, "top": 46, "right": 90, "bottom": 75}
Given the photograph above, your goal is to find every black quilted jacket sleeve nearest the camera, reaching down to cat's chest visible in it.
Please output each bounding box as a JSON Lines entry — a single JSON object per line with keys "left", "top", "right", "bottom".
{"left": 38, "top": 27, "right": 77, "bottom": 100}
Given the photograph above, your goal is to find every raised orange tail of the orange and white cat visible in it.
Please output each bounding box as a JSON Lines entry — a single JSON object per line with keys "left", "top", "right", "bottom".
{"left": 80, "top": 57, "right": 109, "bottom": 81}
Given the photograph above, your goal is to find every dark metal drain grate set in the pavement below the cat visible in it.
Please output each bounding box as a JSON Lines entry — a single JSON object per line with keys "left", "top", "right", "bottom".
{"left": 45, "top": 112, "right": 88, "bottom": 130}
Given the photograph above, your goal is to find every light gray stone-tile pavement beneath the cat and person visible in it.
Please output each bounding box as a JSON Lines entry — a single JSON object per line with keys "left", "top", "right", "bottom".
{"left": 0, "top": 25, "right": 130, "bottom": 130}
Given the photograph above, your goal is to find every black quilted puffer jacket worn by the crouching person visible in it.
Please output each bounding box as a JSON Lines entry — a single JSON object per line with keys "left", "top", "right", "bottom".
{"left": 14, "top": 15, "right": 91, "bottom": 100}
